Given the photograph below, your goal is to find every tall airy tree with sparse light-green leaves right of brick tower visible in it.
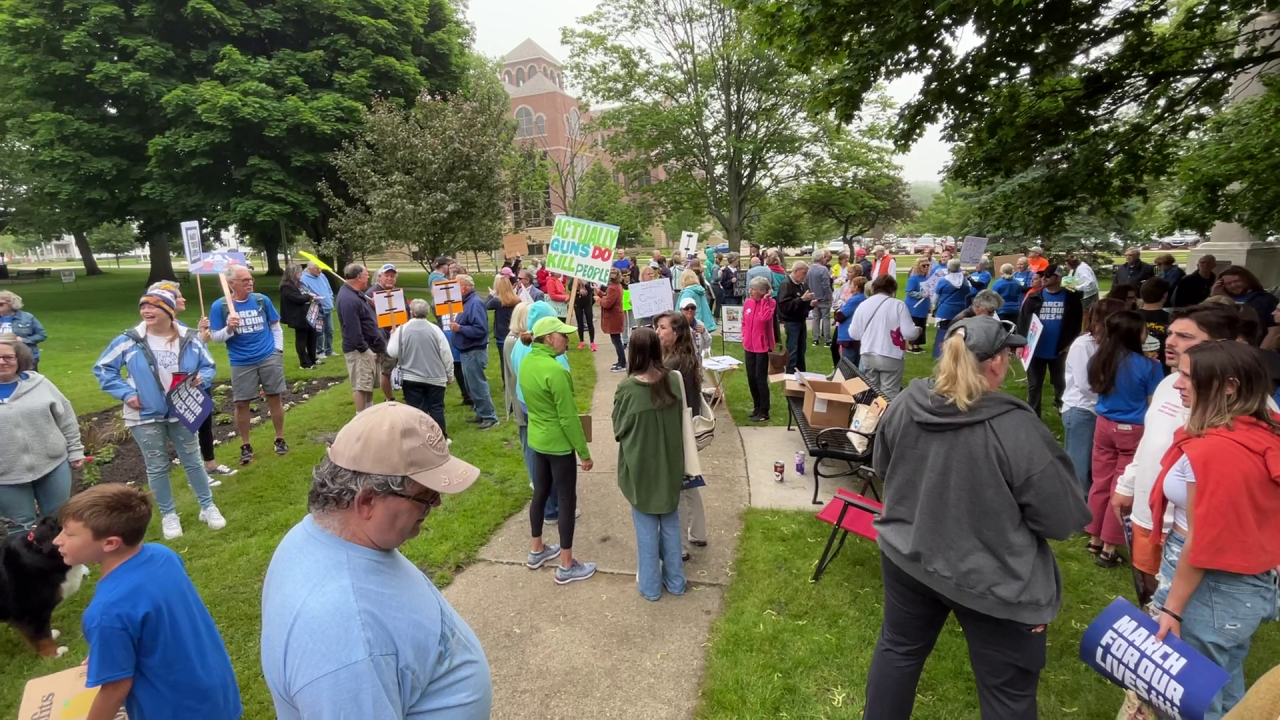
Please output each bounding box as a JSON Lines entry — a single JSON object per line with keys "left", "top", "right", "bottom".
{"left": 562, "top": 0, "right": 813, "bottom": 246}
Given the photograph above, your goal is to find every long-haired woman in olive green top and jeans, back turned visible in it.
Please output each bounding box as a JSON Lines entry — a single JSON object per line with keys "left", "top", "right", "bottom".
{"left": 613, "top": 328, "right": 685, "bottom": 602}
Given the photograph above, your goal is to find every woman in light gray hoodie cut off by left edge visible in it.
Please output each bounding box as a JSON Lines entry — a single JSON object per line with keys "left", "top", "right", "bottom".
{"left": 0, "top": 334, "right": 84, "bottom": 534}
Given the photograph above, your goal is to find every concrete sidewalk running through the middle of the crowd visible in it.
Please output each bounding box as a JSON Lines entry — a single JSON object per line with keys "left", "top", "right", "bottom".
{"left": 444, "top": 338, "right": 748, "bottom": 719}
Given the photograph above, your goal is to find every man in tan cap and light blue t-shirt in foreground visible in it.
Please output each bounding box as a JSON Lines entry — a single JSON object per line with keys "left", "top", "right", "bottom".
{"left": 261, "top": 402, "right": 493, "bottom": 720}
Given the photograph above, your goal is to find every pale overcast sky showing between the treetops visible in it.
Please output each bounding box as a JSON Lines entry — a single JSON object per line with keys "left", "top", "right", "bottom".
{"left": 468, "top": 0, "right": 950, "bottom": 181}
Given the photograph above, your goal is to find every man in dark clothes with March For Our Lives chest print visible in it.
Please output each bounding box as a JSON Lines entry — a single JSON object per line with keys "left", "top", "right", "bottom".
{"left": 1018, "top": 264, "right": 1084, "bottom": 416}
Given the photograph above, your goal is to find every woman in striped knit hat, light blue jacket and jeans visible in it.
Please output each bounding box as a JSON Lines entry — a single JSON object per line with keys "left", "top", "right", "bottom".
{"left": 93, "top": 291, "right": 227, "bottom": 539}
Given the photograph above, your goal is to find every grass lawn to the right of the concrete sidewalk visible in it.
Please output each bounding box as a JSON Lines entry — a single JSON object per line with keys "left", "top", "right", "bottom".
{"left": 698, "top": 272, "right": 1280, "bottom": 720}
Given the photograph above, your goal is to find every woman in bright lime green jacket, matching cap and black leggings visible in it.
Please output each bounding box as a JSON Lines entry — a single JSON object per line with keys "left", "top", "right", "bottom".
{"left": 520, "top": 318, "right": 595, "bottom": 585}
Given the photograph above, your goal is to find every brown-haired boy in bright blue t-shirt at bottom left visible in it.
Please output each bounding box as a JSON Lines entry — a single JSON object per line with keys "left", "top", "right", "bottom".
{"left": 54, "top": 483, "right": 243, "bottom": 720}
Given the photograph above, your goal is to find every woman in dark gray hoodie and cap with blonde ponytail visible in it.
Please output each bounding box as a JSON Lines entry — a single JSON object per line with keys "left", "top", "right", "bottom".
{"left": 863, "top": 315, "right": 1091, "bottom": 720}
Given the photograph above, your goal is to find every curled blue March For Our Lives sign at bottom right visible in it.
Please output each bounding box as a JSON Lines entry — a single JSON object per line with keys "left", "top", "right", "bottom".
{"left": 1080, "top": 597, "right": 1229, "bottom": 720}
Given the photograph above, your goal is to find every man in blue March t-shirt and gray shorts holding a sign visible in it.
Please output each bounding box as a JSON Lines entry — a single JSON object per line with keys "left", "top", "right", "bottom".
{"left": 200, "top": 265, "right": 289, "bottom": 465}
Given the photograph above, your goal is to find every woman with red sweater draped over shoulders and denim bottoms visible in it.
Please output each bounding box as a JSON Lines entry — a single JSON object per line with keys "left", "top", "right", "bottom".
{"left": 1151, "top": 341, "right": 1280, "bottom": 720}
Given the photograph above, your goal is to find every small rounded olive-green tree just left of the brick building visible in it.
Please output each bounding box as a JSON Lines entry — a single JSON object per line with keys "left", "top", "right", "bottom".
{"left": 320, "top": 67, "right": 518, "bottom": 268}
